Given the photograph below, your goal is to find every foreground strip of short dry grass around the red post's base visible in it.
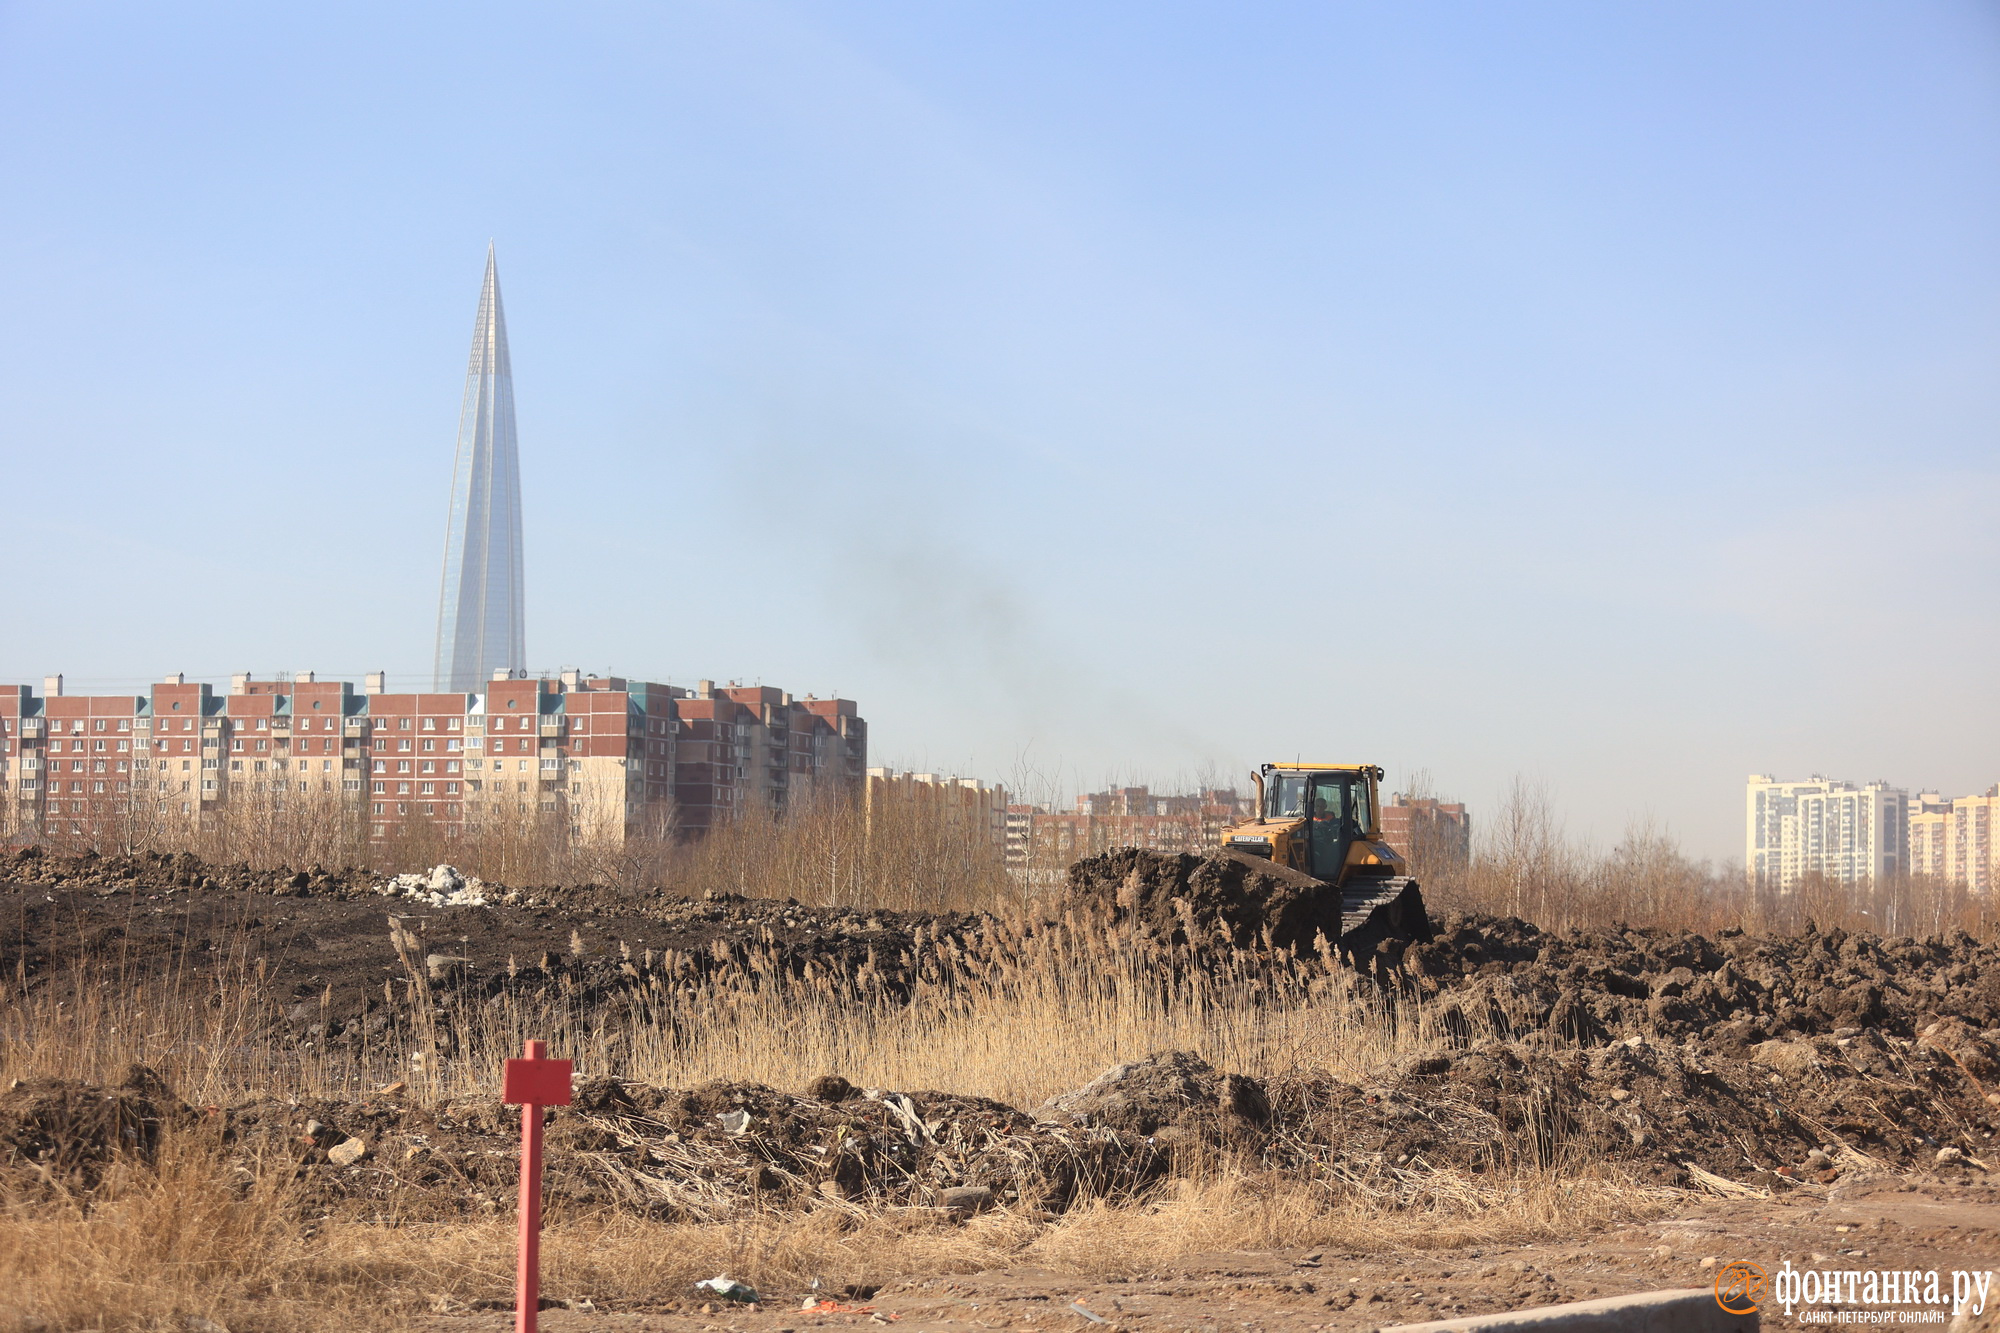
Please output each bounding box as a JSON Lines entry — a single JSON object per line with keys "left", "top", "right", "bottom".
{"left": 0, "top": 1153, "right": 1678, "bottom": 1333}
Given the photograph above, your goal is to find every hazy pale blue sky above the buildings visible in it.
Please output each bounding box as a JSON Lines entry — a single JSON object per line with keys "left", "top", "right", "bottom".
{"left": 0, "top": 0, "right": 2000, "bottom": 857}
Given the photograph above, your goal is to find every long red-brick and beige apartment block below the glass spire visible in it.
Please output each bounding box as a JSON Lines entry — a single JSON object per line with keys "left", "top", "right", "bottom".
{"left": 0, "top": 671, "right": 868, "bottom": 839}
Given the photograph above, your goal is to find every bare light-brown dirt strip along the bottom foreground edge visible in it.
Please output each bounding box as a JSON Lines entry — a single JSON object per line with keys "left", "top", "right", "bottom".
{"left": 416, "top": 1177, "right": 2000, "bottom": 1333}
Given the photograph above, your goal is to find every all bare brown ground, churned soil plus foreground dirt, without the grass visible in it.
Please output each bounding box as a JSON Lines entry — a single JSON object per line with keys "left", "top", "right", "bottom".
{"left": 0, "top": 853, "right": 2000, "bottom": 1333}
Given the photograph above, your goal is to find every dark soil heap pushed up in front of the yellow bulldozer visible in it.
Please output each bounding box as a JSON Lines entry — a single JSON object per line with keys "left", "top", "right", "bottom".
{"left": 1064, "top": 847, "right": 1340, "bottom": 957}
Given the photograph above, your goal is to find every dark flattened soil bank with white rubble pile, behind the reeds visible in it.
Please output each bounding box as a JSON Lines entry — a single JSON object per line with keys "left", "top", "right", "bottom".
{"left": 0, "top": 849, "right": 990, "bottom": 1055}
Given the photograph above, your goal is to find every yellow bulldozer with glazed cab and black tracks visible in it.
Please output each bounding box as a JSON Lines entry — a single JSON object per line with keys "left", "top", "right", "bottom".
{"left": 1222, "top": 765, "right": 1436, "bottom": 969}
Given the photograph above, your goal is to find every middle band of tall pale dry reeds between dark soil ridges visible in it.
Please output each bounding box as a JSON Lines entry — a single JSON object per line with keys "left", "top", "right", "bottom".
{"left": 0, "top": 908, "right": 1434, "bottom": 1107}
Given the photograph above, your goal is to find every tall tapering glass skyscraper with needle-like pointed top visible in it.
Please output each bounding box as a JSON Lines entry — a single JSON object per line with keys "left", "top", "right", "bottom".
{"left": 436, "top": 244, "right": 528, "bottom": 693}
